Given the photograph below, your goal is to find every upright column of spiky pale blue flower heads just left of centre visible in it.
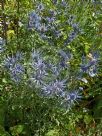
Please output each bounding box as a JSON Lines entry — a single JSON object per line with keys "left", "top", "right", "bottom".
{"left": 28, "top": 50, "right": 47, "bottom": 86}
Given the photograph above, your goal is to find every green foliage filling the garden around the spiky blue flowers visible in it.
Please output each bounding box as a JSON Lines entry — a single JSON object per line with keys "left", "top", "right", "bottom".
{"left": 0, "top": 0, "right": 102, "bottom": 136}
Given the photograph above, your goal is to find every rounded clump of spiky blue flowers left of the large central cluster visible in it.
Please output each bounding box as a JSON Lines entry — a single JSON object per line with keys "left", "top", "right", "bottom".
{"left": 3, "top": 52, "right": 25, "bottom": 83}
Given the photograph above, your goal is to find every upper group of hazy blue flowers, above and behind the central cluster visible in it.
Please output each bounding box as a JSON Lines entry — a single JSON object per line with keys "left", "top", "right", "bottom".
{"left": 28, "top": 1, "right": 80, "bottom": 45}
